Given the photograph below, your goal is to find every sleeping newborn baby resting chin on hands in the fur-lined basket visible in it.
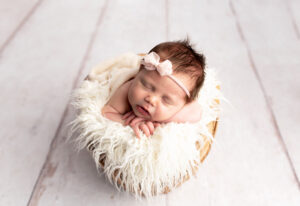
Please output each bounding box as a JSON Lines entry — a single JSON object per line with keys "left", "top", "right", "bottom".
{"left": 102, "top": 40, "right": 205, "bottom": 137}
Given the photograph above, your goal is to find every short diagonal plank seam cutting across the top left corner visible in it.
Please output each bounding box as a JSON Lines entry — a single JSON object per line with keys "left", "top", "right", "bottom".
{"left": 0, "top": 0, "right": 43, "bottom": 58}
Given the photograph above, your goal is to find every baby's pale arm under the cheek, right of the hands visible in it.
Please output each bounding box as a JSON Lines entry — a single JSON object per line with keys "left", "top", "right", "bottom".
{"left": 165, "top": 101, "right": 202, "bottom": 123}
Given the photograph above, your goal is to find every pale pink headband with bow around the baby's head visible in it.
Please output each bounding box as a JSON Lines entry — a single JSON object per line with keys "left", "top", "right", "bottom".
{"left": 141, "top": 52, "right": 190, "bottom": 97}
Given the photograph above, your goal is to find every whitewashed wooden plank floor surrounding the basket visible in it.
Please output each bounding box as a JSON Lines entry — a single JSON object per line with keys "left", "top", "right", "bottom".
{"left": 0, "top": 0, "right": 300, "bottom": 206}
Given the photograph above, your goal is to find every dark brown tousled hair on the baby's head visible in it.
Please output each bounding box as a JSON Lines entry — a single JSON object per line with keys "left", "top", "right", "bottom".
{"left": 149, "top": 38, "right": 205, "bottom": 103}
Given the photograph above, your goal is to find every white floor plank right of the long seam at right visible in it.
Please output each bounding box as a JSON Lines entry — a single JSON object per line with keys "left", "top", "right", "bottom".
{"left": 234, "top": 0, "right": 300, "bottom": 189}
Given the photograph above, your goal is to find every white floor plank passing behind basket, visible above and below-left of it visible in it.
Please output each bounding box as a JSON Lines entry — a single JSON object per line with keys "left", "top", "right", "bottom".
{"left": 30, "top": 0, "right": 166, "bottom": 206}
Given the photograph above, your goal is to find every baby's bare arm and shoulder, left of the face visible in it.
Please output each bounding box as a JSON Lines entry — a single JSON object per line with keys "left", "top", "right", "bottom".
{"left": 102, "top": 81, "right": 131, "bottom": 124}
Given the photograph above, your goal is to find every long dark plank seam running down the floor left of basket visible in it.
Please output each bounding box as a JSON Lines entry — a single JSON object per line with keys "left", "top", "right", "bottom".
{"left": 27, "top": 0, "right": 109, "bottom": 206}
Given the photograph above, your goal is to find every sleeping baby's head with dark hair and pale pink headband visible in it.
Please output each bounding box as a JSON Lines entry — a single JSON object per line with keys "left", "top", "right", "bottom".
{"left": 128, "top": 40, "right": 205, "bottom": 121}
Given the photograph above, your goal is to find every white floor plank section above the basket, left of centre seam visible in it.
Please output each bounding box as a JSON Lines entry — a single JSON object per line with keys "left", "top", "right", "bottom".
{"left": 85, "top": 0, "right": 167, "bottom": 73}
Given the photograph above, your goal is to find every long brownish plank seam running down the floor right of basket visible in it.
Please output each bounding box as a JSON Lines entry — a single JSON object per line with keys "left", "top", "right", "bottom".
{"left": 229, "top": 0, "right": 300, "bottom": 190}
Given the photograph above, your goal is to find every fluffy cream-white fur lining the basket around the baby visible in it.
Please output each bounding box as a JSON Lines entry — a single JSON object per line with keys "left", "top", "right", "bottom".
{"left": 67, "top": 53, "right": 223, "bottom": 197}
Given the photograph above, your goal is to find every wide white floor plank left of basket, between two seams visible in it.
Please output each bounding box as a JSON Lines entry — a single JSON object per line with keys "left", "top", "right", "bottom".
{"left": 0, "top": 0, "right": 106, "bottom": 205}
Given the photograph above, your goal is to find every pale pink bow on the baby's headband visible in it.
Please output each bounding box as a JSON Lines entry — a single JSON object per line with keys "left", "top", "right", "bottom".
{"left": 142, "top": 52, "right": 173, "bottom": 76}
